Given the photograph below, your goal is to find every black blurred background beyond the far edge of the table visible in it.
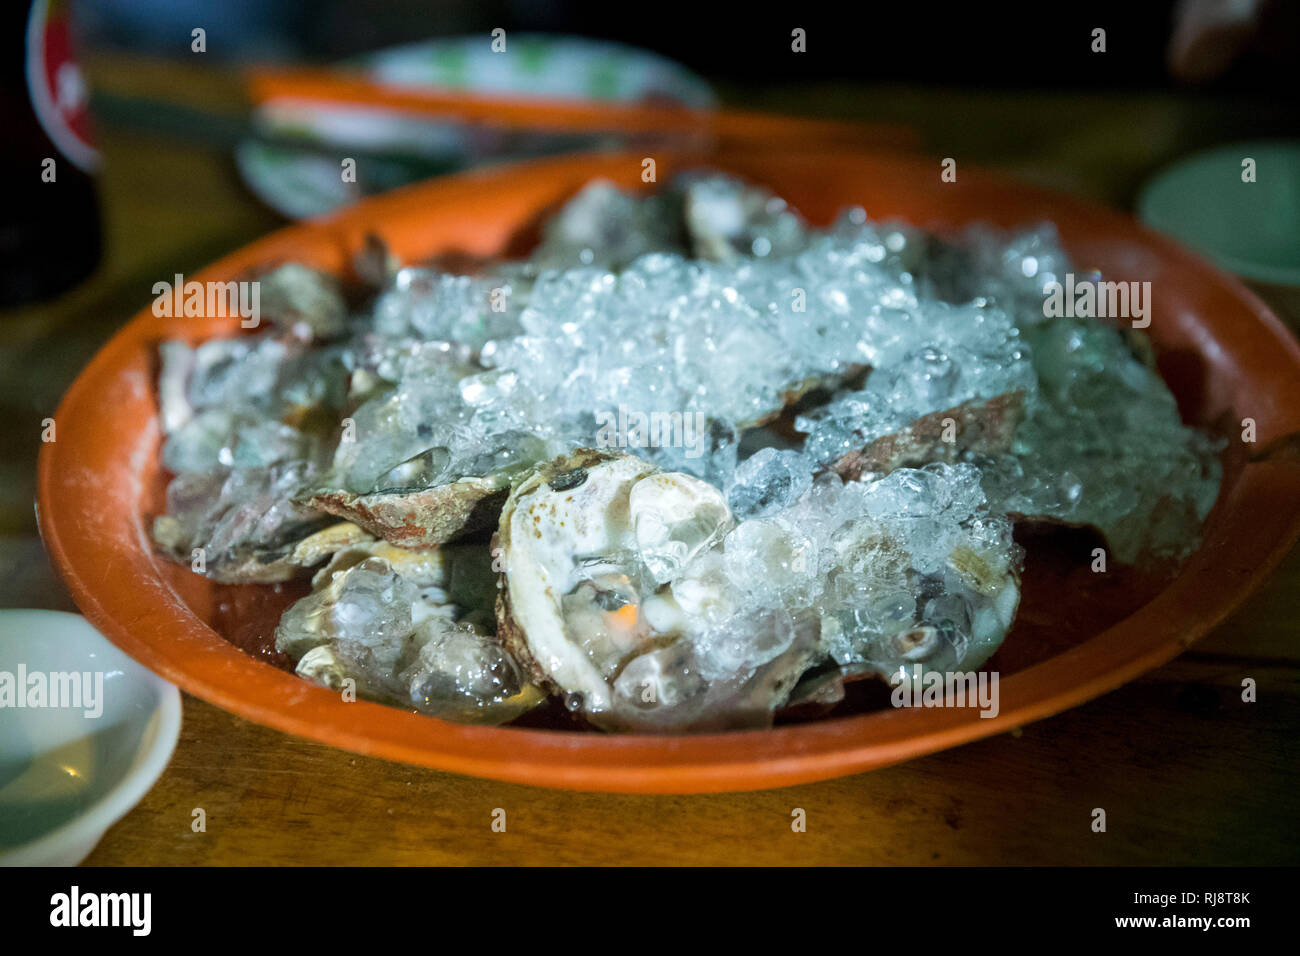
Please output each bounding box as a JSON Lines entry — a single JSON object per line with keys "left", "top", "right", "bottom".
{"left": 75, "top": 0, "right": 1300, "bottom": 99}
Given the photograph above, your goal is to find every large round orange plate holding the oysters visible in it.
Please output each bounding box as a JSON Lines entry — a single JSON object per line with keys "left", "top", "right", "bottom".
{"left": 39, "top": 152, "right": 1300, "bottom": 792}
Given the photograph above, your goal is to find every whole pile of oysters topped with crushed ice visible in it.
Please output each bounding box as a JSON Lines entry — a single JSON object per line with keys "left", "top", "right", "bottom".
{"left": 152, "top": 170, "right": 1219, "bottom": 734}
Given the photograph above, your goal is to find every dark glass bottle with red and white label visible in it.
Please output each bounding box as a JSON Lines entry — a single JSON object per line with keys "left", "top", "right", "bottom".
{"left": 0, "top": 0, "right": 100, "bottom": 308}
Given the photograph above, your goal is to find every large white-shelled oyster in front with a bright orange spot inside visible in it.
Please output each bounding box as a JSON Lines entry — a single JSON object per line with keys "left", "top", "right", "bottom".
{"left": 495, "top": 451, "right": 816, "bottom": 730}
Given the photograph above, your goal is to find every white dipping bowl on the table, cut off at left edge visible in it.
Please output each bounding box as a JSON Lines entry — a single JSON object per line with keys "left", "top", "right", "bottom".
{"left": 0, "top": 610, "right": 181, "bottom": 866}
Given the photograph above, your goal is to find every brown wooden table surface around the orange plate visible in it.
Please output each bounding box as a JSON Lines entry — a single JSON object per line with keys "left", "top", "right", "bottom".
{"left": 0, "top": 57, "right": 1300, "bottom": 865}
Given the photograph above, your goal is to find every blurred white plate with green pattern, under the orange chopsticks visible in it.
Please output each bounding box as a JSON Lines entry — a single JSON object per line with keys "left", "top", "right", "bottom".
{"left": 235, "top": 34, "right": 716, "bottom": 219}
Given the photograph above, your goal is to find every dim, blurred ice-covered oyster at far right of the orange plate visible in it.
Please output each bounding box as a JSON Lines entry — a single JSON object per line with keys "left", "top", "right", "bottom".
{"left": 975, "top": 319, "right": 1225, "bottom": 564}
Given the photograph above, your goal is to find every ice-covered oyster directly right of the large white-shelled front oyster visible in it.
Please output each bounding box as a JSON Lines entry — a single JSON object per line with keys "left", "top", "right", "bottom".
{"left": 722, "top": 455, "right": 1021, "bottom": 678}
